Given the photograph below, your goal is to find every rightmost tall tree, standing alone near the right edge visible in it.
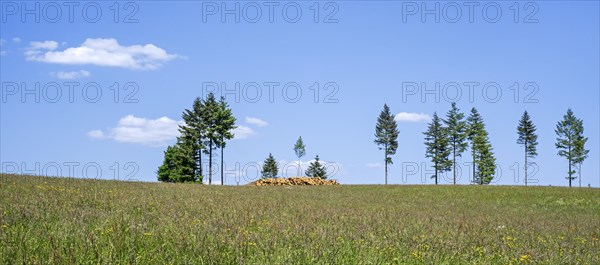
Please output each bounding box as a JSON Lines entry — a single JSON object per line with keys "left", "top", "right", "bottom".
{"left": 554, "top": 108, "right": 588, "bottom": 187}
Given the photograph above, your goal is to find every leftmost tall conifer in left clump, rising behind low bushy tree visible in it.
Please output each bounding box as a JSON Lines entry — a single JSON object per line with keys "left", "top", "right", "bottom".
{"left": 179, "top": 98, "right": 207, "bottom": 181}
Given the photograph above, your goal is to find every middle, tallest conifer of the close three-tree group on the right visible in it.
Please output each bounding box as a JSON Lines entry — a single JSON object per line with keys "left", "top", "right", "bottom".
{"left": 443, "top": 103, "right": 468, "bottom": 185}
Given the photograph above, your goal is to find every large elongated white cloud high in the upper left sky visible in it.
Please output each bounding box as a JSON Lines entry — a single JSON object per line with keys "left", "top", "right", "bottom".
{"left": 25, "top": 38, "right": 178, "bottom": 70}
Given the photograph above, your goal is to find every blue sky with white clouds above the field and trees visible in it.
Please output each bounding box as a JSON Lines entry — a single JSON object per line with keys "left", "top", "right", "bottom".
{"left": 0, "top": 1, "right": 600, "bottom": 187}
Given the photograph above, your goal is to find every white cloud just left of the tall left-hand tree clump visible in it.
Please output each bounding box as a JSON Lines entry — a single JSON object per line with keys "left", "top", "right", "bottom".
{"left": 87, "top": 115, "right": 181, "bottom": 146}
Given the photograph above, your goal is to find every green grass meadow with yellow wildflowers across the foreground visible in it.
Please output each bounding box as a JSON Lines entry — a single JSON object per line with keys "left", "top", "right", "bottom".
{"left": 0, "top": 175, "right": 600, "bottom": 264}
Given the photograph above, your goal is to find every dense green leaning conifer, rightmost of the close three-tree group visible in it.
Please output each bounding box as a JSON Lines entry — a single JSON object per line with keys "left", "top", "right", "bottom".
{"left": 467, "top": 108, "right": 496, "bottom": 185}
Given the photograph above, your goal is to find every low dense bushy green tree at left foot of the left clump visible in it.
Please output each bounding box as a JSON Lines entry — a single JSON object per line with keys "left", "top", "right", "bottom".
{"left": 157, "top": 142, "right": 197, "bottom": 182}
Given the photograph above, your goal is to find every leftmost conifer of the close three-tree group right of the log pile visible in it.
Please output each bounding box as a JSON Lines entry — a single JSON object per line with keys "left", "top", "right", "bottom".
{"left": 423, "top": 112, "right": 452, "bottom": 185}
